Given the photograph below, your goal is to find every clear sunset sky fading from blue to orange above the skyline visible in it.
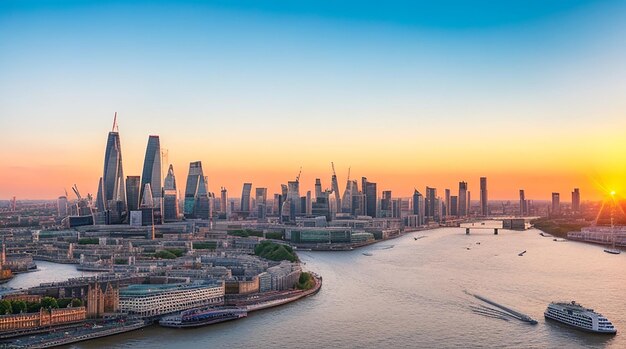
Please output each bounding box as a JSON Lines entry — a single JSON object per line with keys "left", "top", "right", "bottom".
{"left": 0, "top": 0, "right": 626, "bottom": 201}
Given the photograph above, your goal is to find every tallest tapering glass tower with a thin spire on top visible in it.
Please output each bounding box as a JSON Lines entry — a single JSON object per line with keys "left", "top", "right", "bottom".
{"left": 102, "top": 113, "right": 126, "bottom": 223}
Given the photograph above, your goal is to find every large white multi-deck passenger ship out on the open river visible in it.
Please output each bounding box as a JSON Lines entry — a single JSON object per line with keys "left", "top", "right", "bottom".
{"left": 543, "top": 301, "right": 617, "bottom": 334}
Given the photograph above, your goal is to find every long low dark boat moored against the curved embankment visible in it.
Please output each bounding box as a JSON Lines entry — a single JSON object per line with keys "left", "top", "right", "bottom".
{"left": 159, "top": 307, "right": 248, "bottom": 328}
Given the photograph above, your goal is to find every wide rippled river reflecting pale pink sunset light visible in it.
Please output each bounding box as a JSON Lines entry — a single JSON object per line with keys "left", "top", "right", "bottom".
{"left": 7, "top": 228, "right": 626, "bottom": 348}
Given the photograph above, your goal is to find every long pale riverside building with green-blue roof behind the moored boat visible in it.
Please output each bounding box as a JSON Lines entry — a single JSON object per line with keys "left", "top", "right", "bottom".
{"left": 119, "top": 282, "right": 225, "bottom": 317}
